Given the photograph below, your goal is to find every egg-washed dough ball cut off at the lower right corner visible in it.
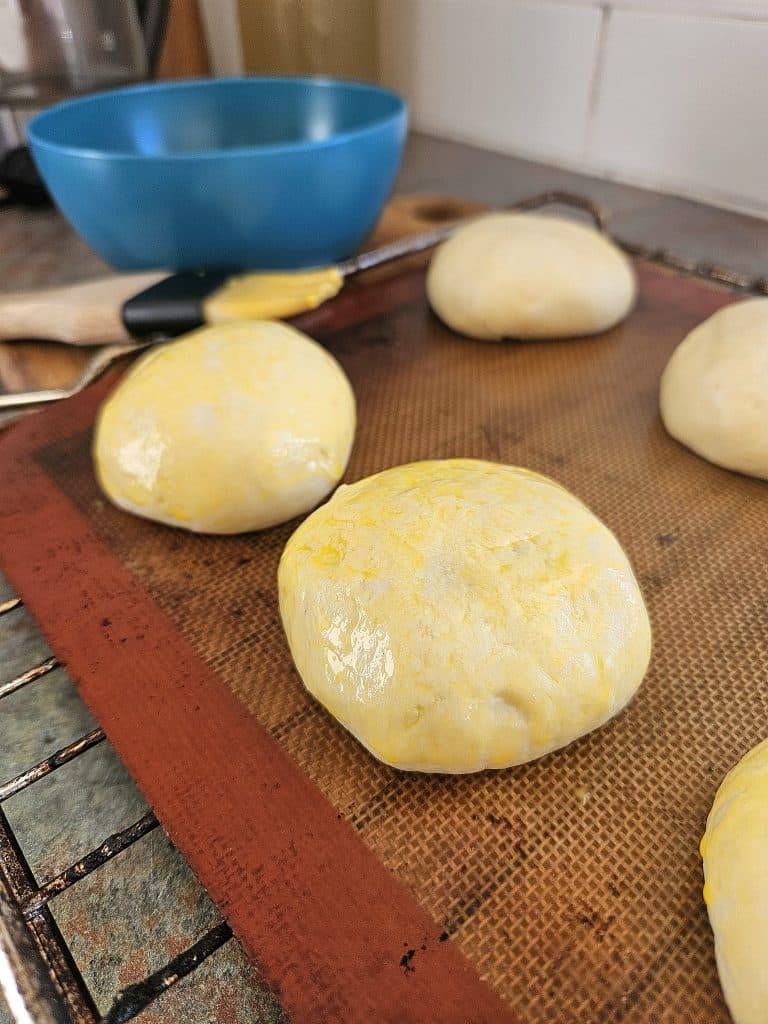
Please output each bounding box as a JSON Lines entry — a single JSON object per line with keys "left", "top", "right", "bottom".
{"left": 701, "top": 739, "right": 768, "bottom": 1024}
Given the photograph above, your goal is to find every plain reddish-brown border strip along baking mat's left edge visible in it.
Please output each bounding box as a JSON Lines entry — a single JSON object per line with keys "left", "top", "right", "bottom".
{"left": 0, "top": 381, "right": 517, "bottom": 1024}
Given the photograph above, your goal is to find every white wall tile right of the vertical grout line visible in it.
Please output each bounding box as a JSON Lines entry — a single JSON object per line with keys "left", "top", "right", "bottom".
{"left": 587, "top": 10, "right": 768, "bottom": 213}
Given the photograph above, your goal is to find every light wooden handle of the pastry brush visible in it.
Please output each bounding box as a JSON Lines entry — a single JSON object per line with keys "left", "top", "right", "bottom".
{"left": 0, "top": 270, "right": 167, "bottom": 345}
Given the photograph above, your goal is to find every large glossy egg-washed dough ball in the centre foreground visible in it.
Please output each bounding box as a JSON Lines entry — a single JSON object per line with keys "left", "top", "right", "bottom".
{"left": 279, "top": 459, "right": 650, "bottom": 772}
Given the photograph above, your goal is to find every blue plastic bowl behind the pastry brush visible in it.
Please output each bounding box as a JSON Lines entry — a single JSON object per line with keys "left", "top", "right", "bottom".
{"left": 28, "top": 78, "right": 407, "bottom": 270}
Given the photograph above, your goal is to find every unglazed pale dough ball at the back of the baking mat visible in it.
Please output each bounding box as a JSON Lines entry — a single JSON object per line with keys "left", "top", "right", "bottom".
{"left": 427, "top": 213, "right": 635, "bottom": 341}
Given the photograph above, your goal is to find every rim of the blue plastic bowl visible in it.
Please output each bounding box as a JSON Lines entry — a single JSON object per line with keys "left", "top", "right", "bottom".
{"left": 27, "top": 75, "right": 408, "bottom": 163}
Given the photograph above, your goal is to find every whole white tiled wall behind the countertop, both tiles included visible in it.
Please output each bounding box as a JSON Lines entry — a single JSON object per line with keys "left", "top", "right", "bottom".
{"left": 379, "top": 0, "right": 768, "bottom": 216}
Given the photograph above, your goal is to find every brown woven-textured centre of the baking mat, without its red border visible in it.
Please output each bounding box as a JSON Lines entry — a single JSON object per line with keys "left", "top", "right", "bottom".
{"left": 40, "top": 267, "right": 768, "bottom": 1024}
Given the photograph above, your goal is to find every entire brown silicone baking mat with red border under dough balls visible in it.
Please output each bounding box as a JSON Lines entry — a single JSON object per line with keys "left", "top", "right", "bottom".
{"left": 0, "top": 258, "right": 768, "bottom": 1024}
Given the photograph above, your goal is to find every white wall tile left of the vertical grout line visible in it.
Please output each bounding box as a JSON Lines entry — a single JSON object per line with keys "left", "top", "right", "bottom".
{"left": 379, "top": 0, "right": 601, "bottom": 161}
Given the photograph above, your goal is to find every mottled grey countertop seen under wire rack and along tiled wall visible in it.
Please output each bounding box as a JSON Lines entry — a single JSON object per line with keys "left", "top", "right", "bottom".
{"left": 0, "top": 135, "right": 768, "bottom": 1024}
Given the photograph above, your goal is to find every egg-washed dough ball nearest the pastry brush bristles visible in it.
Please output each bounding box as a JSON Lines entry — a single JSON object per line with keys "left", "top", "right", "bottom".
{"left": 94, "top": 321, "right": 355, "bottom": 534}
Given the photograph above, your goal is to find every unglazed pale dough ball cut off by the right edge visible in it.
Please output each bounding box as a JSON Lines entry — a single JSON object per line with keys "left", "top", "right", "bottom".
{"left": 660, "top": 299, "right": 768, "bottom": 479}
